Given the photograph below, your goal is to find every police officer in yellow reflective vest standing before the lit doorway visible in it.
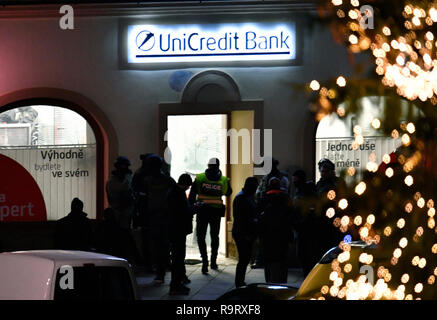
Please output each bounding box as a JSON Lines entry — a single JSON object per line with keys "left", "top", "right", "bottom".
{"left": 189, "top": 158, "right": 232, "bottom": 274}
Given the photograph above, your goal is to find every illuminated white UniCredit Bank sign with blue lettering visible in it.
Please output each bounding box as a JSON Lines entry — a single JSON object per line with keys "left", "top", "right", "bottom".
{"left": 127, "top": 23, "right": 296, "bottom": 63}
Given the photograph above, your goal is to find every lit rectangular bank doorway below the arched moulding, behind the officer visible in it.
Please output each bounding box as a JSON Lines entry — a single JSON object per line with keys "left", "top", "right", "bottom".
{"left": 160, "top": 102, "right": 262, "bottom": 259}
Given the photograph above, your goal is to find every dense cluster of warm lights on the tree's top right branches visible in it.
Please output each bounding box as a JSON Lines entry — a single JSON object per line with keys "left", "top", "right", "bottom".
{"left": 325, "top": 0, "right": 437, "bottom": 105}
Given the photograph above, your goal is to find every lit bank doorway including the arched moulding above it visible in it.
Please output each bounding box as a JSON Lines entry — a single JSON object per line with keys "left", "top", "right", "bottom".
{"left": 159, "top": 70, "right": 264, "bottom": 257}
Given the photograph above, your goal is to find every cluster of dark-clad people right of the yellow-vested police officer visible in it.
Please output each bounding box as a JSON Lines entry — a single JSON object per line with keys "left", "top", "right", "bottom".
{"left": 232, "top": 159, "right": 343, "bottom": 287}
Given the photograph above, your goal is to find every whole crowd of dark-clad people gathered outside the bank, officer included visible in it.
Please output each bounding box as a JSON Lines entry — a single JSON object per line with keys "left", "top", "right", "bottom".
{"left": 55, "top": 154, "right": 340, "bottom": 295}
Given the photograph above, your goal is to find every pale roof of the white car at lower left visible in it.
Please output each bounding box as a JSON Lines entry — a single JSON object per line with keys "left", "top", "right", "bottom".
{"left": 2, "top": 250, "right": 126, "bottom": 263}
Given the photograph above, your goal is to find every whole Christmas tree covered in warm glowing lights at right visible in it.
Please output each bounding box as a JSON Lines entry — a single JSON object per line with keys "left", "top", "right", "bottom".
{"left": 308, "top": 0, "right": 437, "bottom": 300}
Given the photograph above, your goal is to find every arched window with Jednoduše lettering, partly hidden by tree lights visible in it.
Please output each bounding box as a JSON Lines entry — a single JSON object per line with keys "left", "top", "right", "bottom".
{"left": 315, "top": 96, "right": 420, "bottom": 183}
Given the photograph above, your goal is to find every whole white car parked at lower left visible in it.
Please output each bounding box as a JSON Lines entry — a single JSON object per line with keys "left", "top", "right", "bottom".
{"left": 0, "top": 250, "right": 138, "bottom": 300}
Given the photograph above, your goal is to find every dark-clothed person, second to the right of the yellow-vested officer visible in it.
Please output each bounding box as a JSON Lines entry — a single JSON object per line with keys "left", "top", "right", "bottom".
{"left": 258, "top": 177, "right": 293, "bottom": 283}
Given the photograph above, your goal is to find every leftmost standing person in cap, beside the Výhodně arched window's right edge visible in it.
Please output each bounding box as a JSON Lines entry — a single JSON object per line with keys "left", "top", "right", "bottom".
{"left": 106, "top": 156, "right": 135, "bottom": 229}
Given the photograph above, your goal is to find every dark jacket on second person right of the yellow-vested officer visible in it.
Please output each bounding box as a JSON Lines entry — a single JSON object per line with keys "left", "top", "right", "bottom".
{"left": 259, "top": 192, "right": 293, "bottom": 262}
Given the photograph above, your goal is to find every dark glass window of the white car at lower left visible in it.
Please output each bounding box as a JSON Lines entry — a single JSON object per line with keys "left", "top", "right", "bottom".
{"left": 54, "top": 265, "right": 134, "bottom": 300}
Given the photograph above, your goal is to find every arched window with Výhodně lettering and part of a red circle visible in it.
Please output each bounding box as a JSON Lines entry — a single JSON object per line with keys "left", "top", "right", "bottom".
{"left": 0, "top": 105, "right": 97, "bottom": 221}
